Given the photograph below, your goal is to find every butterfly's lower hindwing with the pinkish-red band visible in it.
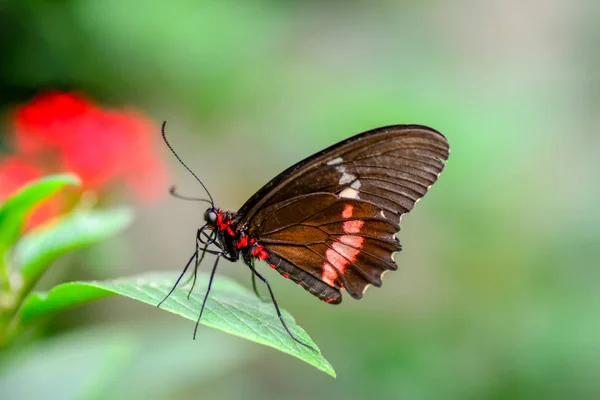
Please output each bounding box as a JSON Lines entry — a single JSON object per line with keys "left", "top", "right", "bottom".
{"left": 250, "top": 193, "right": 400, "bottom": 298}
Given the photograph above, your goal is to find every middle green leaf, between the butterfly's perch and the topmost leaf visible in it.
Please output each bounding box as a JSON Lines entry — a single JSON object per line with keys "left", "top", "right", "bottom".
{"left": 14, "top": 208, "right": 133, "bottom": 294}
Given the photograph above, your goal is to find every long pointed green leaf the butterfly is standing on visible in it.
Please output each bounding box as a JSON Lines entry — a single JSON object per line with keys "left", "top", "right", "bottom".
{"left": 22, "top": 273, "right": 335, "bottom": 377}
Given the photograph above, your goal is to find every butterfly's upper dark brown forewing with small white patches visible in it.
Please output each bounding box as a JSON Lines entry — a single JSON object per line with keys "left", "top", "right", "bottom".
{"left": 237, "top": 125, "right": 449, "bottom": 225}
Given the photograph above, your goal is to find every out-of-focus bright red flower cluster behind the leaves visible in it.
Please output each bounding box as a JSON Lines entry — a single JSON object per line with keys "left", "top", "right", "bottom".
{"left": 0, "top": 92, "right": 167, "bottom": 227}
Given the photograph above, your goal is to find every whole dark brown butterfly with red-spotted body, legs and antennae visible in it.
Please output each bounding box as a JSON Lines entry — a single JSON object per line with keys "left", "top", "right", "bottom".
{"left": 158, "top": 121, "right": 450, "bottom": 351}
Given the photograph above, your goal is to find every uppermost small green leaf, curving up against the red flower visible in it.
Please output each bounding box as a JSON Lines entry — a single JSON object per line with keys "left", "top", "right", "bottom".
{"left": 0, "top": 174, "right": 79, "bottom": 254}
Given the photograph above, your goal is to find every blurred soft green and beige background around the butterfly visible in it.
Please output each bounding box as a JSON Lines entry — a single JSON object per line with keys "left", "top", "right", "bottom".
{"left": 0, "top": 0, "right": 600, "bottom": 400}
